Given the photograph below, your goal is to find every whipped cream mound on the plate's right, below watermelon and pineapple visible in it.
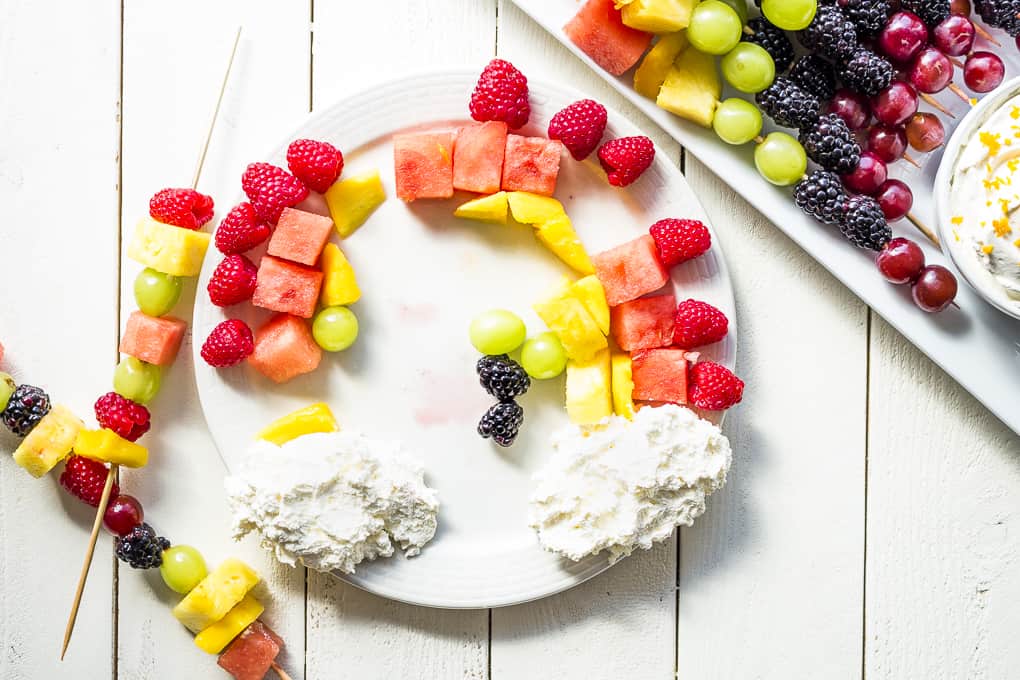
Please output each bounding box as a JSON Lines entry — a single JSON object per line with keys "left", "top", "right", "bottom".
{"left": 528, "top": 405, "right": 732, "bottom": 563}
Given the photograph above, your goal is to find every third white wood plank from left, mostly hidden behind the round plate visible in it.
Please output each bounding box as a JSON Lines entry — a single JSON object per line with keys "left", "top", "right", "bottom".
{"left": 308, "top": 0, "right": 496, "bottom": 678}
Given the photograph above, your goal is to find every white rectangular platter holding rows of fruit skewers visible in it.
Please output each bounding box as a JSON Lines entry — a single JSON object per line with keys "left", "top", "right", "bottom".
{"left": 513, "top": 0, "right": 1020, "bottom": 433}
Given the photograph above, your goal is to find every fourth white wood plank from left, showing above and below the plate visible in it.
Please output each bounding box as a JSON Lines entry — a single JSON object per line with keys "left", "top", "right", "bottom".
{"left": 492, "top": 2, "right": 680, "bottom": 679}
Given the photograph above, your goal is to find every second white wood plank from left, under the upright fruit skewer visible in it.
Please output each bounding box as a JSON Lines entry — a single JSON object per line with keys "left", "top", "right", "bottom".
{"left": 119, "top": 0, "right": 310, "bottom": 680}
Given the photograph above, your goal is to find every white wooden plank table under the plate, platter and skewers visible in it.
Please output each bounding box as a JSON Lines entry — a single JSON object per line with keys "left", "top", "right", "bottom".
{"left": 0, "top": 0, "right": 1020, "bottom": 680}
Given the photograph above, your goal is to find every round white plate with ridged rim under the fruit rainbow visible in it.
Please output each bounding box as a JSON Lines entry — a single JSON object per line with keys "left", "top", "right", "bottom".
{"left": 194, "top": 72, "right": 736, "bottom": 608}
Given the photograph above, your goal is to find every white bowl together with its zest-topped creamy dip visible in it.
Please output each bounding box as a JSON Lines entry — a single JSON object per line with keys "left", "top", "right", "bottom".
{"left": 934, "top": 79, "right": 1020, "bottom": 318}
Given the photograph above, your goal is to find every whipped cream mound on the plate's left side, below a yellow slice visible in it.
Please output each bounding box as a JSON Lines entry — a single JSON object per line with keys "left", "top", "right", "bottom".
{"left": 225, "top": 431, "right": 440, "bottom": 574}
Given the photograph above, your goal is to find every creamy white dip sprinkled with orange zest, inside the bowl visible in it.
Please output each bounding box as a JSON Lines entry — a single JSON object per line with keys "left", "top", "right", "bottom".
{"left": 949, "top": 96, "right": 1020, "bottom": 310}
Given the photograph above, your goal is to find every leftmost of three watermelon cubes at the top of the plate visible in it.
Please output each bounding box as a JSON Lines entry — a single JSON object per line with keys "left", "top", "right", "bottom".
{"left": 393, "top": 132, "right": 454, "bottom": 203}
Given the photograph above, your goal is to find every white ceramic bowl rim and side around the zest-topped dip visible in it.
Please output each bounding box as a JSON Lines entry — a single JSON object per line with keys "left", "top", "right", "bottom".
{"left": 933, "top": 77, "right": 1020, "bottom": 319}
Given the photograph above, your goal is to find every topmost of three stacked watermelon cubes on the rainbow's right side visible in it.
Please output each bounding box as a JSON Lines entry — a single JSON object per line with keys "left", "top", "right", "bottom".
{"left": 592, "top": 233, "right": 669, "bottom": 307}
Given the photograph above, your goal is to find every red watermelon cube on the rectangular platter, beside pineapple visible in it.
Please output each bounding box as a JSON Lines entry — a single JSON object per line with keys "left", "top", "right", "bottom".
{"left": 563, "top": 0, "right": 652, "bottom": 75}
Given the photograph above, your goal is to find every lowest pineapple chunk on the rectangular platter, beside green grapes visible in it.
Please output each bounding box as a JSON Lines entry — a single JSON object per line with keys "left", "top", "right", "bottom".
{"left": 655, "top": 50, "right": 722, "bottom": 127}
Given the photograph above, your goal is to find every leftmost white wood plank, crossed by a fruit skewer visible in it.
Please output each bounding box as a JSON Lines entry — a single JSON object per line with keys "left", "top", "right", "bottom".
{"left": 0, "top": 0, "right": 120, "bottom": 679}
